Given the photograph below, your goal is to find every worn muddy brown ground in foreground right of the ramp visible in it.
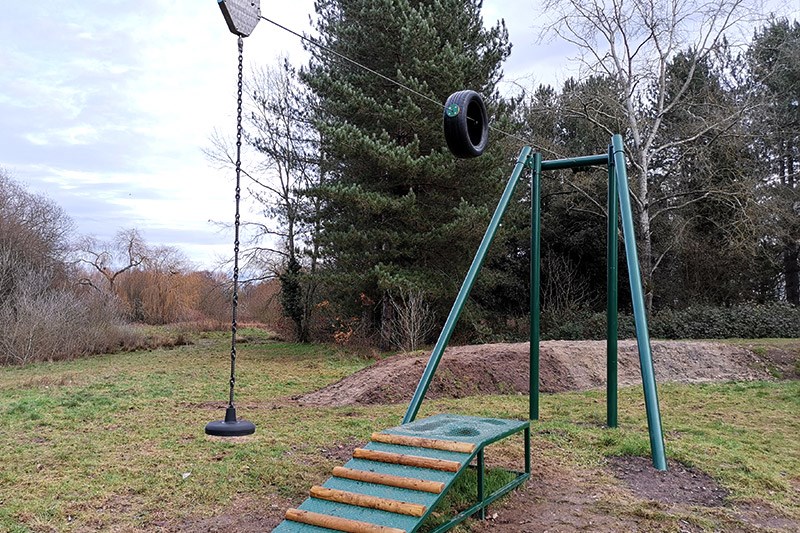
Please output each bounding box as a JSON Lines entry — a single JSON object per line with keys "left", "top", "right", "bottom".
{"left": 470, "top": 456, "right": 800, "bottom": 533}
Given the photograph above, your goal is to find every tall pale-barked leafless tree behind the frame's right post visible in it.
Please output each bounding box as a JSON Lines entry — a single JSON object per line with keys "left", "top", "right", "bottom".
{"left": 544, "top": 0, "right": 759, "bottom": 305}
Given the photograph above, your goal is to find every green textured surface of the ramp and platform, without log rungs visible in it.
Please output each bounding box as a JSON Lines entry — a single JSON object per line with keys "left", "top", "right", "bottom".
{"left": 273, "top": 414, "right": 529, "bottom": 533}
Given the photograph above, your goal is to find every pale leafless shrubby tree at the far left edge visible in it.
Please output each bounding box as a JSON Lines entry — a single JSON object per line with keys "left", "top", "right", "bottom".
{"left": 0, "top": 172, "right": 130, "bottom": 364}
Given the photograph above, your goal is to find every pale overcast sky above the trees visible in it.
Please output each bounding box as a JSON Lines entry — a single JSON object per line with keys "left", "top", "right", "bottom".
{"left": 0, "top": 0, "right": 800, "bottom": 268}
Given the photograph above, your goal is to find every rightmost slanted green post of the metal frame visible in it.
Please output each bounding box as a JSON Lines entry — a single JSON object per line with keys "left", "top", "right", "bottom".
{"left": 611, "top": 135, "right": 667, "bottom": 470}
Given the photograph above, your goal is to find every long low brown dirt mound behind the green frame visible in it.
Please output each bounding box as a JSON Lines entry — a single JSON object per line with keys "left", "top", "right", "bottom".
{"left": 295, "top": 340, "right": 770, "bottom": 406}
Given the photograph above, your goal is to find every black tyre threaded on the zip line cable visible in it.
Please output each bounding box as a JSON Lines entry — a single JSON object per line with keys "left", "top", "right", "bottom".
{"left": 444, "top": 90, "right": 489, "bottom": 159}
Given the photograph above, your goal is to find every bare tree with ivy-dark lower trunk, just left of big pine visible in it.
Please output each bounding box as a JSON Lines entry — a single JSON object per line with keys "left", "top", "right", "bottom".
{"left": 206, "top": 58, "right": 321, "bottom": 341}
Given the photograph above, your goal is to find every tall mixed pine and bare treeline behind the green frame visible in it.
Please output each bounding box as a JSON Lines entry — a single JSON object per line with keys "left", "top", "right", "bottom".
{"left": 225, "top": 0, "right": 800, "bottom": 349}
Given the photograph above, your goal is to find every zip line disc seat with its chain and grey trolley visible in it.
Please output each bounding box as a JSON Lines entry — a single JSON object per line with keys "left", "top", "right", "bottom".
{"left": 206, "top": 0, "right": 261, "bottom": 437}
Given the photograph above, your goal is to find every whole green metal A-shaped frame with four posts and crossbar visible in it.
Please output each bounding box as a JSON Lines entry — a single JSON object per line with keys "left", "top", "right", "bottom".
{"left": 403, "top": 135, "right": 667, "bottom": 470}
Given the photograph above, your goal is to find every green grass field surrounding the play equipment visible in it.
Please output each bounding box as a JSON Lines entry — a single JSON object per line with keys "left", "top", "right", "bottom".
{"left": 0, "top": 330, "right": 800, "bottom": 532}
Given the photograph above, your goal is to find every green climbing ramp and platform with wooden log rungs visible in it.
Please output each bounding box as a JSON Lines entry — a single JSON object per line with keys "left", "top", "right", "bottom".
{"left": 273, "top": 414, "right": 530, "bottom": 533}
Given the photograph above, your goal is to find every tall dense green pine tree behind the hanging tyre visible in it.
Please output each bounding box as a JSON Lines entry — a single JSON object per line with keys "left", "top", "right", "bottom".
{"left": 302, "top": 0, "right": 510, "bottom": 338}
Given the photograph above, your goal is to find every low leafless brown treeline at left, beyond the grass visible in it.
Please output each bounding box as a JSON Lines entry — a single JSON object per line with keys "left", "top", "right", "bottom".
{"left": 0, "top": 167, "right": 286, "bottom": 364}
